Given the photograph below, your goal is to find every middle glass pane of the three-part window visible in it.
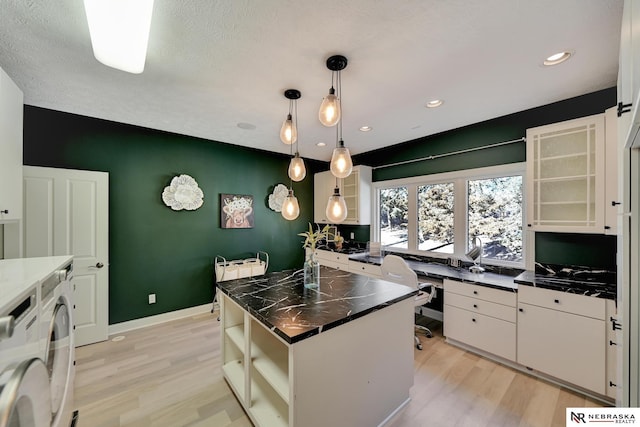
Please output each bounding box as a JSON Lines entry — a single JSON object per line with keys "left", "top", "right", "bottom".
{"left": 418, "top": 182, "right": 455, "bottom": 254}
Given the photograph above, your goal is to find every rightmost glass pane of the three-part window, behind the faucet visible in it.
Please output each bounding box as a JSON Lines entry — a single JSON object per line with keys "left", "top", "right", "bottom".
{"left": 467, "top": 176, "right": 522, "bottom": 262}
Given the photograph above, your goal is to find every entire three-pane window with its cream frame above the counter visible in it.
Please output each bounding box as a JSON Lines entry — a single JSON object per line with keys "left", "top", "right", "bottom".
{"left": 371, "top": 163, "right": 526, "bottom": 267}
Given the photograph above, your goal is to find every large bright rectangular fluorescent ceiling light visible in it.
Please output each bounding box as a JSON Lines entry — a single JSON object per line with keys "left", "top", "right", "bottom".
{"left": 84, "top": 0, "right": 153, "bottom": 74}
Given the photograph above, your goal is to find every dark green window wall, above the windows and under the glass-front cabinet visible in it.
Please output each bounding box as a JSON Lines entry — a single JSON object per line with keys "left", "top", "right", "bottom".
{"left": 353, "top": 87, "right": 617, "bottom": 270}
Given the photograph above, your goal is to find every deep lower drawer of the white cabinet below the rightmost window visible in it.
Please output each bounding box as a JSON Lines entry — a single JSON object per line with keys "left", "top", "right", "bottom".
{"left": 443, "top": 304, "right": 516, "bottom": 361}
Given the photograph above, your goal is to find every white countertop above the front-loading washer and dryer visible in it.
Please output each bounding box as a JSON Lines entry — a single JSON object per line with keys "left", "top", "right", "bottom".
{"left": 0, "top": 255, "right": 73, "bottom": 313}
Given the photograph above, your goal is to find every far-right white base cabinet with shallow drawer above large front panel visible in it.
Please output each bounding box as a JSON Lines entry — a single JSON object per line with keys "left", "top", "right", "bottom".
{"left": 517, "top": 286, "right": 606, "bottom": 395}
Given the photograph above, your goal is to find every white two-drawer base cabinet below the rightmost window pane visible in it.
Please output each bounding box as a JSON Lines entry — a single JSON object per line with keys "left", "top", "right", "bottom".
{"left": 443, "top": 279, "right": 517, "bottom": 361}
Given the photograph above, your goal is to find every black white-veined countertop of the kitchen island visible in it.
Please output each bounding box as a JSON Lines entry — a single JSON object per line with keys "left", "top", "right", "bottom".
{"left": 216, "top": 267, "right": 418, "bottom": 344}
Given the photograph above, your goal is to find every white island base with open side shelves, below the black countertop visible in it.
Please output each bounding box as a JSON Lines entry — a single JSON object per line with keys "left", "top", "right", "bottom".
{"left": 220, "top": 292, "right": 413, "bottom": 427}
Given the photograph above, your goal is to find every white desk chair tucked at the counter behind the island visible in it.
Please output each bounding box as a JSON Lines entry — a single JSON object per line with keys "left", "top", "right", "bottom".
{"left": 380, "top": 255, "right": 436, "bottom": 350}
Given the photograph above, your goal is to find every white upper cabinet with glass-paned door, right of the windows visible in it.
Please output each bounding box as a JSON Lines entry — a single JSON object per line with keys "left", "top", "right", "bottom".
{"left": 527, "top": 114, "right": 605, "bottom": 233}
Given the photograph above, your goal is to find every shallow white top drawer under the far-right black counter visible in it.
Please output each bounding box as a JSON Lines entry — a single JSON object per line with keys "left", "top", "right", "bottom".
{"left": 518, "top": 285, "right": 606, "bottom": 320}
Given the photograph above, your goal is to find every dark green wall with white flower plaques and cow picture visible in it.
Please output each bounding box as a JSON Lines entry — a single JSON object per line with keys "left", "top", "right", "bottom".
{"left": 24, "top": 106, "right": 326, "bottom": 324}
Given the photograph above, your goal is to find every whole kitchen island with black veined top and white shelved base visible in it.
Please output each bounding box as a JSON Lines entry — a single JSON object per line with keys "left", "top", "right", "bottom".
{"left": 217, "top": 267, "right": 417, "bottom": 427}
